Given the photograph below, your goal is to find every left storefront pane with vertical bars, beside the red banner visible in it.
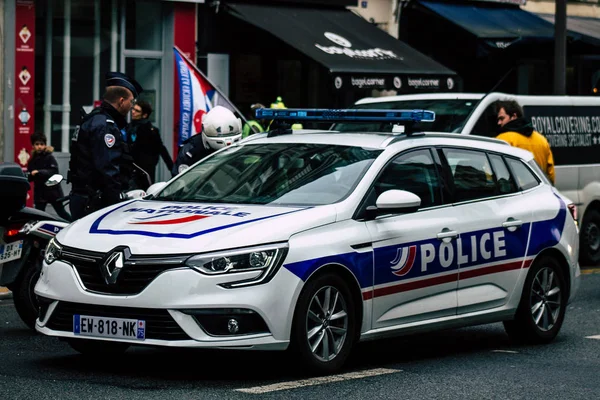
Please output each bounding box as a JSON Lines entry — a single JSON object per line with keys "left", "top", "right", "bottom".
{"left": 35, "top": 0, "right": 120, "bottom": 152}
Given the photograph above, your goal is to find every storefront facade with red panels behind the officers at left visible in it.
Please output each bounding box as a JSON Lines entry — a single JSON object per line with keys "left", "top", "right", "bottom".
{"left": 0, "top": 0, "right": 203, "bottom": 198}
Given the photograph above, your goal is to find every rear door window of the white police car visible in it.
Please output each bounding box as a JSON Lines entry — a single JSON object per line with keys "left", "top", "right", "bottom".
{"left": 443, "top": 149, "right": 496, "bottom": 202}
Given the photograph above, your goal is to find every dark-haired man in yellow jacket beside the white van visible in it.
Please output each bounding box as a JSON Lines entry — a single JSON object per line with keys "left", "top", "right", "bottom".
{"left": 496, "top": 100, "right": 554, "bottom": 184}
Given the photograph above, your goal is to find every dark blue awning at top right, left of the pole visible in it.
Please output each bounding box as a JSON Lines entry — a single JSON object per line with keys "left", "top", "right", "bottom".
{"left": 419, "top": 0, "right": 572, "bottom": 48}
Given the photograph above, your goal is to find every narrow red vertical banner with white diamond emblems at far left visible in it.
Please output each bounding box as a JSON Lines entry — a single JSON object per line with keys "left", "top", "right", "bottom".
{"left": 14, "top": 0, "right": 35, "bottom": 206}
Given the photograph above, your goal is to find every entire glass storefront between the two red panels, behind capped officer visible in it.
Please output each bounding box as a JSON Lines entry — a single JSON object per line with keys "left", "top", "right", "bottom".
{"left": 35, "top": 0, "right": 164, "bottom": 152}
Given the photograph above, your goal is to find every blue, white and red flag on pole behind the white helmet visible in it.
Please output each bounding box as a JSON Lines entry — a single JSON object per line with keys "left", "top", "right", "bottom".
{"left": 173, "top": 46, "right": 247, "bottom": 146}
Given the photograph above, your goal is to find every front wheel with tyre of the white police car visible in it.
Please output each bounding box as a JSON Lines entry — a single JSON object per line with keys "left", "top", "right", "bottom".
{"left": 290, "top": 274, "right": 356, "bottom": 374}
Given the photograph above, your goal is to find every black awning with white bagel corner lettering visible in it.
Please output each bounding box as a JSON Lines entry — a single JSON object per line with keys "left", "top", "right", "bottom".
{"left": 227, "top": 3, "right": 457, "bottom": 90}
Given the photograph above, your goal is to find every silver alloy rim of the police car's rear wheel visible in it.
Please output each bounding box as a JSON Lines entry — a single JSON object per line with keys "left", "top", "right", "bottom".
{"left": 529, "top": 267, "right": 562, "bottom": 332}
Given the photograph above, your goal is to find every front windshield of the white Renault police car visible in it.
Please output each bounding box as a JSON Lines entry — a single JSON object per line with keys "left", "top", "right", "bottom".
{"left": 154, "top": 143, "right": 381, "bottom": 205}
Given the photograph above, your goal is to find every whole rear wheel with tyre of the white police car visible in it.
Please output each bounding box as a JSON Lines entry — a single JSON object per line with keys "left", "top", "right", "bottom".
{"left": 504, "top": 256, "right": 567, "bottom": 343}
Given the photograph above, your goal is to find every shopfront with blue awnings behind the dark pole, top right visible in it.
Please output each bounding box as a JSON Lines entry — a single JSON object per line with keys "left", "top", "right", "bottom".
{"left": 353, "top": 0, "right": 600, "bottom": 95}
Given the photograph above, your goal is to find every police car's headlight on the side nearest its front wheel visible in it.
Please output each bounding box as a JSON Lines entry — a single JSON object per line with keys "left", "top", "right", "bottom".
{"left": 185, "top": 243, "right": 288, "bottom": 288}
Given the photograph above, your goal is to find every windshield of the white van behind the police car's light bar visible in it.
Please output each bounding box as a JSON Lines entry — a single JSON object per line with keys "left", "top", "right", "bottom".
{"left": 331, "top": 99, "right": 477, "bottom": 132}
